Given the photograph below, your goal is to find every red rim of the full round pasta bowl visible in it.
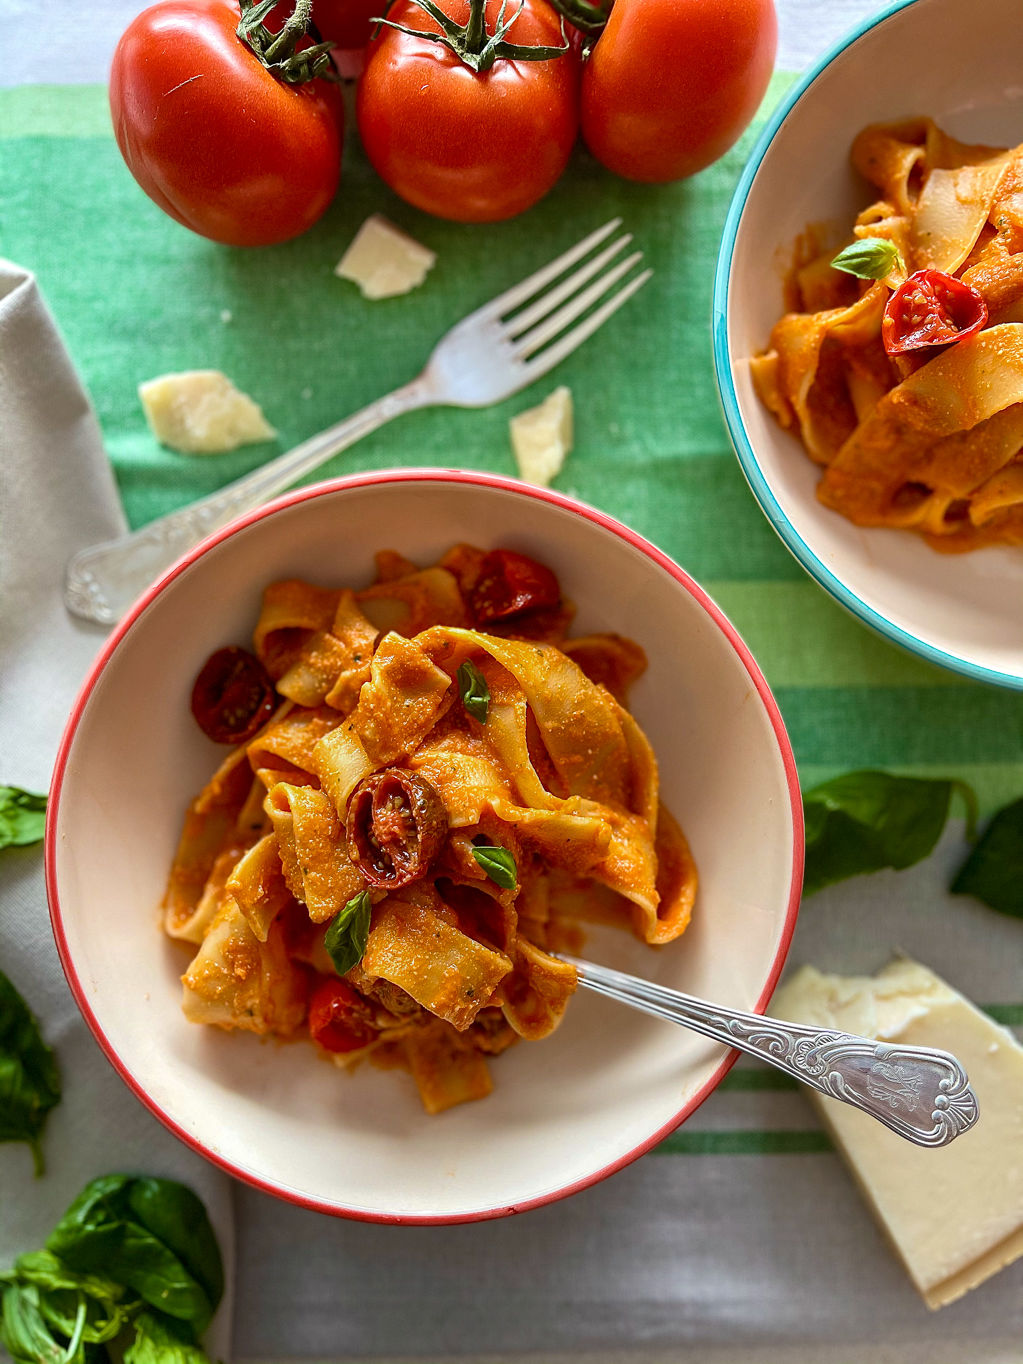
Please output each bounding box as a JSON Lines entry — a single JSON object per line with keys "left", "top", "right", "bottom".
{"left": 45, "top": 468, "right": 803, "bottom": 1226}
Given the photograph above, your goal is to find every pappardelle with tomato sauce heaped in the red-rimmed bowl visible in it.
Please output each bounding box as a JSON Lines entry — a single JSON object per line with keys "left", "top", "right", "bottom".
{"left": 162, "top": 544, "right": 697, "bottom": 1113}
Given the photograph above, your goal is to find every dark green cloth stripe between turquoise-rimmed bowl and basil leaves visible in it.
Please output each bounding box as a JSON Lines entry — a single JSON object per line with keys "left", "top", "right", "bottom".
{"left": 775, "top": 692, "right": 1023, "bottom": 769}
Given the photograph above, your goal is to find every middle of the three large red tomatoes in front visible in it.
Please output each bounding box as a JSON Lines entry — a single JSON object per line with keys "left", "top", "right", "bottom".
{"left": 356, "top": 0, "right": 578, "bottom": 222}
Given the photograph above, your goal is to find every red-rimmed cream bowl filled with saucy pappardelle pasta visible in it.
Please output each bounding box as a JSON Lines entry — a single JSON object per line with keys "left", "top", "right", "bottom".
{"left": 46, "top": 471, "right": 802, "bottom": 1222}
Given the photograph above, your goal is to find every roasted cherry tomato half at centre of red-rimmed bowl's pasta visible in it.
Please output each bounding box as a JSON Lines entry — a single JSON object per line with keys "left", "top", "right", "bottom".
{"left": 346, "top": 768, "right": 447, "bottom": 891}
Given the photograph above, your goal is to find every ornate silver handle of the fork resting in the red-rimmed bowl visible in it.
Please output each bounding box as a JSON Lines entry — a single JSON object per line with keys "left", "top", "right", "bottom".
{"left": 565, "top": 958, "right": 978, "bottom": 1146}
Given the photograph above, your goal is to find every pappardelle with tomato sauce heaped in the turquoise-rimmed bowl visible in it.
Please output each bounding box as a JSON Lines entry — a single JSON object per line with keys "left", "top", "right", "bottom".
{"left": 752, "top": 119, "right": 1023, "bottom": 551}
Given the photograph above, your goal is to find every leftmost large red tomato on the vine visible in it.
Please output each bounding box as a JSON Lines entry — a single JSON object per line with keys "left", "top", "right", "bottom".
{"left": 110, "top": 0, "right": 342, "bottom": 247}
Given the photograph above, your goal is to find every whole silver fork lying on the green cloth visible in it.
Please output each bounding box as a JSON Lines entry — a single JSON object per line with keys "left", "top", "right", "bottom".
{"left": 64, "top": 218, "right": 652, "bottom": 625}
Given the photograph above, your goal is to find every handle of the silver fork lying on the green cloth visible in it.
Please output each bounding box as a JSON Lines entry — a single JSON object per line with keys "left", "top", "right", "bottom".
{"left": 64, "top": 375, "right": 434, "bottom": 625}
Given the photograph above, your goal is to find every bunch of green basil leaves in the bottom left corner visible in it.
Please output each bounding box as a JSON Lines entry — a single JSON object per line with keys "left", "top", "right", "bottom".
{"left": 0, "top": 1174, "right": 224, "bottom": 1364}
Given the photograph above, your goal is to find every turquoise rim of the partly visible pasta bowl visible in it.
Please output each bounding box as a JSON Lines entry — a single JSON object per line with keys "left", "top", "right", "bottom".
{"left": 711, "top": 0, "right": 1023, "bottom": 690}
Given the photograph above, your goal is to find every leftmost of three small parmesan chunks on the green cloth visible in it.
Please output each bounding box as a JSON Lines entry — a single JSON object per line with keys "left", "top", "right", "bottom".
{"left": 139, "top": 370, "right": 277, "bottom": 454}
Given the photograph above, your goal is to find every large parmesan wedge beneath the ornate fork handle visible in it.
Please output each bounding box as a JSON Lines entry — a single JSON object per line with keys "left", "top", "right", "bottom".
{"left": 771, "top": 959, "right": 1023, "bottom": 1308}
